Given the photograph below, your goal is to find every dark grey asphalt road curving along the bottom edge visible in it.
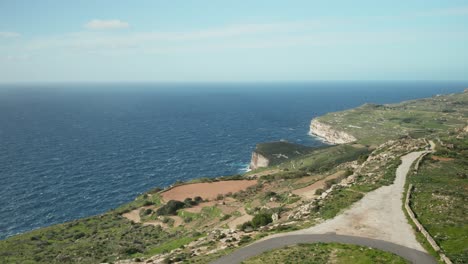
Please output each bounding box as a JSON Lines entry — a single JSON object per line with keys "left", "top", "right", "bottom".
{"left": 212, "top": 234, "right": 437, "bottom": 264}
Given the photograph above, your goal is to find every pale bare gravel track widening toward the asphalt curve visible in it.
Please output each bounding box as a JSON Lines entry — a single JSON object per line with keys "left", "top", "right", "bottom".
{"left": 298, "top": 151, "right": 425, "bottom": 251}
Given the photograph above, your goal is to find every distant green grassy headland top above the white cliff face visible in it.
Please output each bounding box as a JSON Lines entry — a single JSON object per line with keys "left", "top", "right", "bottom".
{"left": 318, "top": 92, "right": 468, "bottom": 144}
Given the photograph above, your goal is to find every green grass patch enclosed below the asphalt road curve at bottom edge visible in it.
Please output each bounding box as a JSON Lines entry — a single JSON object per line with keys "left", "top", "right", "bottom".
{"left": 242, "top": 243, "right": 409, "bottom": 264}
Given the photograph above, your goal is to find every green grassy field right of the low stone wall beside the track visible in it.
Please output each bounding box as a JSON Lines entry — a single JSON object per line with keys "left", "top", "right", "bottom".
{"left": 409, "top": 133, "right": 468, "bottom": 263}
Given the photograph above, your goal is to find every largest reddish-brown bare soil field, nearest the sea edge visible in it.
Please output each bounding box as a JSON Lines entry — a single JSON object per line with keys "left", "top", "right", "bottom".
{"left": 161, "top": 180, "right": 257, "bottom": 201}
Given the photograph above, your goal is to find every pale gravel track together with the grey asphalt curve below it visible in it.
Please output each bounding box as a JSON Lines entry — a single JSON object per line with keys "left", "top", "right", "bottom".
{"left": 212, "top": 151, "right": 437, "bottom": 264}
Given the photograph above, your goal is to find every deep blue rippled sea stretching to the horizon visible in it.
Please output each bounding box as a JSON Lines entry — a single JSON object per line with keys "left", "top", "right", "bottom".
{"left": 0, "top": 81, "right": 468, "bottom": 238}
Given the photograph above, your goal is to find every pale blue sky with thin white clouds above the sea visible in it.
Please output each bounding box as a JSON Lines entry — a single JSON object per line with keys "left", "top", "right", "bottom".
{"left": 0, "top": 0, "right": 468, "bottom": 82}
